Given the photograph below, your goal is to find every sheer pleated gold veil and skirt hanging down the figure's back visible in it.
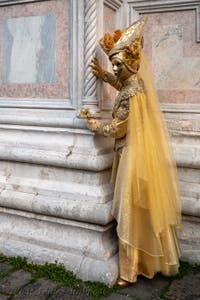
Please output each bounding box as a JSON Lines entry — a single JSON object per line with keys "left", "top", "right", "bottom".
{"left": 112, "top": 54, "right": 181, "bottom": 282}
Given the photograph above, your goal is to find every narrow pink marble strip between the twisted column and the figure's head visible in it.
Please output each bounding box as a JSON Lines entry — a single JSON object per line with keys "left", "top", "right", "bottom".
{"left": 103, "top": 4, "right": 116, "bottom": 109}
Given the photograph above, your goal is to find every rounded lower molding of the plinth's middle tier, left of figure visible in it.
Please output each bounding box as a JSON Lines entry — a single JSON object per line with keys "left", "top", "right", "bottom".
{"left": 0, "top": 190, "right": 113, "bottom": 225}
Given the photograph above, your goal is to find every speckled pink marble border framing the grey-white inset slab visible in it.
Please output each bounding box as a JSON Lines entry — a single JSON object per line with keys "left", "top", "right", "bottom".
{"left": 0, "top": 0, "right": 69, "bottom": 99}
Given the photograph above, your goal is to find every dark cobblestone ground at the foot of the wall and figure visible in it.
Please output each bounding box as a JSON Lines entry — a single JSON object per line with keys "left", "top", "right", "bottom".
{"left": 0, "top": 262, "right": 200, "bottom": 300}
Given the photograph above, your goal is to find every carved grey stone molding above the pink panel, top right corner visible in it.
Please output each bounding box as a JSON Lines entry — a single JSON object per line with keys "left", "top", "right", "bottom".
{"left": 128, "top": 0, "right": 200, "bottom": 42}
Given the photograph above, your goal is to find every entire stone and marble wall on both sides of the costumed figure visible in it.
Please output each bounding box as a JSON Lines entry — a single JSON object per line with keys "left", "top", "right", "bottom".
{"left": 0, "top": 0, "right": 200, "bottom": 284}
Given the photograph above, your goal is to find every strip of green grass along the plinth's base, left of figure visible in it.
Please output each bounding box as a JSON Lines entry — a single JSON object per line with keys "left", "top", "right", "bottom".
{"left": 0, "top": 255, "right": 120, "bottom": 299}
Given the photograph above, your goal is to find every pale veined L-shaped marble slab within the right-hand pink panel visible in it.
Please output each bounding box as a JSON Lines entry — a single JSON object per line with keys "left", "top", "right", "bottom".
{"left": 152, "top": 24, "right": 200, "bottom": 90}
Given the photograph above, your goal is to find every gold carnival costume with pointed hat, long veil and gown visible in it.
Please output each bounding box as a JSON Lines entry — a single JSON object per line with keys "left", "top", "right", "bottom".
{"left": 83, "top": 19, "right": 181, "bottom": 282}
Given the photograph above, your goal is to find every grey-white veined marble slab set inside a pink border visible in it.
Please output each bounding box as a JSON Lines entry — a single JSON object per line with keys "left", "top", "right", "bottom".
{"left": 3, "top": 14, "right": 56, "bottom": 83}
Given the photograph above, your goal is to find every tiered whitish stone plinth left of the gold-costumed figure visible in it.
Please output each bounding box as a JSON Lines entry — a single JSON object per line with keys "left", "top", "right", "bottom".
{"left": 0, "top": 125, "right": 118, "bottom": 284}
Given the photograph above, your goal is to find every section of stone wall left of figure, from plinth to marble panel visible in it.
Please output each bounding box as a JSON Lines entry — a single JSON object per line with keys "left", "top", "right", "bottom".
{"left": 0, "top": 0, "right": 124, "bottom": 284}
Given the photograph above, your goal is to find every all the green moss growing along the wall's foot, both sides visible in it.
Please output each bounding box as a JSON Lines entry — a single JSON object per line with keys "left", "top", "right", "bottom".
{"left": 0, "top": 255, "right": 200, "bottom": 300}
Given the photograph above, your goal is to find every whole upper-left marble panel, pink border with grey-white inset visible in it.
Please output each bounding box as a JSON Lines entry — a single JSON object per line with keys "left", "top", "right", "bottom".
{"left": 0, "top": 0, "right": 70, "bottom": 99}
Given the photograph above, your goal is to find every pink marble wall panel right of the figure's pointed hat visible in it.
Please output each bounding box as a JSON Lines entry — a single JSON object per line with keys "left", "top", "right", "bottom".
{"left": 144, "top": 10, "right": 200, "bottom": 103}
